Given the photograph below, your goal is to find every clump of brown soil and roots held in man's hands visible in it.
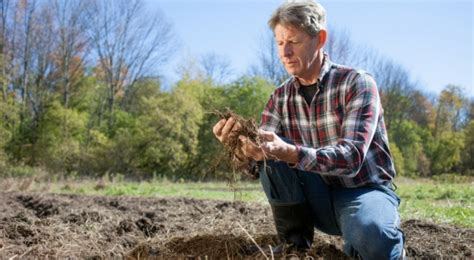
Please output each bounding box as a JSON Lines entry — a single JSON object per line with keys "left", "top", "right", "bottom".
{"left": 214, "top": 109, "right": 262, "bottom": 179}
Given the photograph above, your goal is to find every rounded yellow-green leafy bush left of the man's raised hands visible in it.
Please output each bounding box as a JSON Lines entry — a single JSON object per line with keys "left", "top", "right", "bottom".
{"left": 139, "top": 90, "right": 203, "bottom": 178}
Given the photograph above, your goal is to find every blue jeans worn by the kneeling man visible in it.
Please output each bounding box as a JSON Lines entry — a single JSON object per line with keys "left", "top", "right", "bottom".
{"left": 260, "top": 161, "right": 404, "bottom": 259}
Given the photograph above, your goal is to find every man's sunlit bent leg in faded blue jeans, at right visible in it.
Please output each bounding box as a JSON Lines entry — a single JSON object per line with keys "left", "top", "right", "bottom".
{"left": 332, "top": 187, "right": 404, "bottom": 259}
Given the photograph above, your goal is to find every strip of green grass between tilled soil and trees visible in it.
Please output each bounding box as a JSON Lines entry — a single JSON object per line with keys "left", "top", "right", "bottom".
{"left": 4, "top": 175, "right": 474, "bottom": 228}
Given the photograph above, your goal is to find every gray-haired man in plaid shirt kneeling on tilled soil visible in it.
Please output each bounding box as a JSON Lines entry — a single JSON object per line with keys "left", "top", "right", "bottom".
{"left": 213, "top": 1, "right": 404, "bottom": 259}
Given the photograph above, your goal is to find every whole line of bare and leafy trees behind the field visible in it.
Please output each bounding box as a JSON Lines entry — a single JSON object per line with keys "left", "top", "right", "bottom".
{"left": 0, "top": 0, "right": 474, "bottom": 179}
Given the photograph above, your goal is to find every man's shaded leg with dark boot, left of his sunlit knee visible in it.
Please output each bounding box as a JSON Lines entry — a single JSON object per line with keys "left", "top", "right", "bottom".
{"left": 260, "top": 161, "right": 341, "bottom": 249}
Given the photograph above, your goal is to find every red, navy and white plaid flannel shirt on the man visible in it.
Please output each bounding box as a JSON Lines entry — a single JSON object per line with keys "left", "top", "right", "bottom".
{"left": 260, "top": 54, "right": 395, "bottom": 188}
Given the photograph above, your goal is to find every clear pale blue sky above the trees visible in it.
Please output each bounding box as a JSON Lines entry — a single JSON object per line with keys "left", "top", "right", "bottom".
{"left": 146, "top": 0, "right": 474, "bottom": 97}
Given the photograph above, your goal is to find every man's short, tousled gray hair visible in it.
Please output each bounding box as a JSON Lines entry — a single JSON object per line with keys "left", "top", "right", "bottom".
{"left": 268, "top": 0, "right": 326, "bottom": 36}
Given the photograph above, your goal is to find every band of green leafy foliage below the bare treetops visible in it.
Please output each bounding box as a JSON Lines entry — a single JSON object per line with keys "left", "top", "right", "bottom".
{"left": 0, "top": 54, "right": 474, "bottom": 180}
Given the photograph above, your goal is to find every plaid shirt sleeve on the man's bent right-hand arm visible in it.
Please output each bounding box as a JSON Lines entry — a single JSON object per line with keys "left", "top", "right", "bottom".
{"left": 296, "top": 73, "right": 381, "bottom": 177}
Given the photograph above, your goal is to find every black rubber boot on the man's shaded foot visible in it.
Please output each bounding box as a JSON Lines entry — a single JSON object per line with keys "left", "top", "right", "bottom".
{"left": 270, "top": 200, "right": 314, "bottom": 253}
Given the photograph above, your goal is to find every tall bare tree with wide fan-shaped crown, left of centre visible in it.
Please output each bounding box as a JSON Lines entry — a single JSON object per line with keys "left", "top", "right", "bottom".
{"left": 87, "top": 0, "right": 173, "bottom": 125}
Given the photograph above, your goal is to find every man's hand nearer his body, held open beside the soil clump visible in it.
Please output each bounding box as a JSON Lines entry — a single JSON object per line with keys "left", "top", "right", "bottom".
{"left": 239, "top": 130, "right": 298, "bottom": 164}
